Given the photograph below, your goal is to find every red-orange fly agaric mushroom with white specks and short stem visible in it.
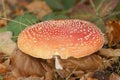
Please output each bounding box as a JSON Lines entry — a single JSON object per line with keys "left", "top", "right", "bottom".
{"left": 18, "top": 19, "right": 104, "bottom": 69}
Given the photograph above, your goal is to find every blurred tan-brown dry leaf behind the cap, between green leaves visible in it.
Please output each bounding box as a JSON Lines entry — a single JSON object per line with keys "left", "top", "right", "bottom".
{"left": 26, "top": 0, "right": 52, "bottom": 19}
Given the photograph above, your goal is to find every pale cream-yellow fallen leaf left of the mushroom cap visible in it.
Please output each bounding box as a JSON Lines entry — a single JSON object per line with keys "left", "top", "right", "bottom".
{"left": 0, "top": 31, "right": 16, "bottom": 55}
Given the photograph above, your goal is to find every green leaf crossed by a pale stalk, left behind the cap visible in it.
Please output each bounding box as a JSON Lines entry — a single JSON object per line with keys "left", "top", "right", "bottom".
{"left": 6, "top": 13, "right": 38, "bottom": 41}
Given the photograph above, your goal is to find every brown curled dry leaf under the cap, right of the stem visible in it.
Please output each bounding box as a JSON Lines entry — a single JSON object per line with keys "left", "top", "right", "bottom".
{"left": 61, "top": 54, "right": 108, "bottom": 71}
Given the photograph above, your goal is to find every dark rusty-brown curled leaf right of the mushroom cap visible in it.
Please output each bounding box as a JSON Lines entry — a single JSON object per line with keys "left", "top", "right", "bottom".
{"left": 106, "top": 20, "right": 120, "bottom": 47}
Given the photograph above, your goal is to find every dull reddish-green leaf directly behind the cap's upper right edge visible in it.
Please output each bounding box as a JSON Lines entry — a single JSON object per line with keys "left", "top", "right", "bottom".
{"left": 70, "top": 2, "right": 95, "bottom": 20}
